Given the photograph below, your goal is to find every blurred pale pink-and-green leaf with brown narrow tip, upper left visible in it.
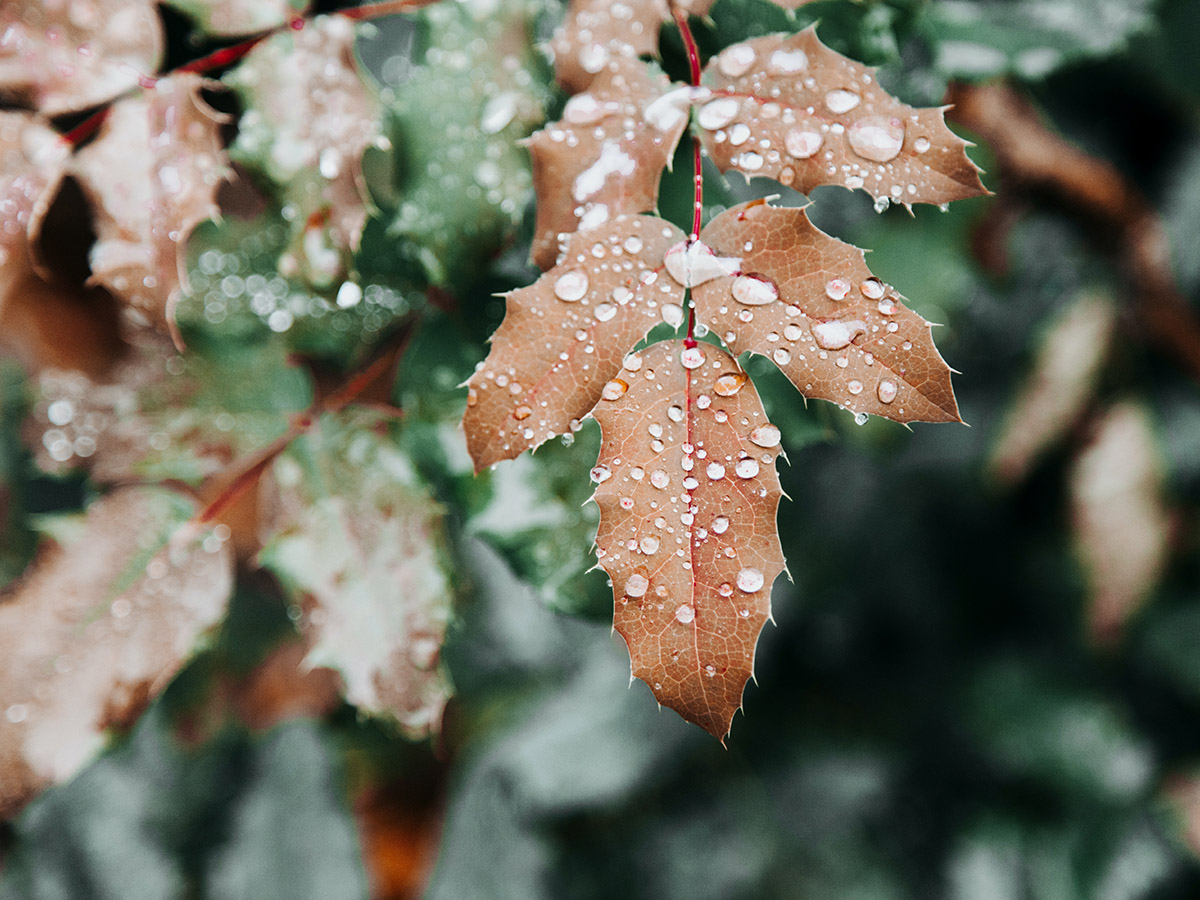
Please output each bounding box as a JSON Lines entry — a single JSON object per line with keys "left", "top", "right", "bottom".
{"left": 224, "top": 16, "right": 383, "bottom": 288}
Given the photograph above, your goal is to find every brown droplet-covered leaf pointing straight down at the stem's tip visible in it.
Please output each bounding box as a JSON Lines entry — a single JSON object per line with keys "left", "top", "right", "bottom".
{"left": 593, "top": 341, "right": 784, "bottom": 738}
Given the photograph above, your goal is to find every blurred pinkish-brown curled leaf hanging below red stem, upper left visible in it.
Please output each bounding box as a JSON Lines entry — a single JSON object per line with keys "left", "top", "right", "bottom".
{"left": 72, "top": 73, "right": 228, "bottom": 329}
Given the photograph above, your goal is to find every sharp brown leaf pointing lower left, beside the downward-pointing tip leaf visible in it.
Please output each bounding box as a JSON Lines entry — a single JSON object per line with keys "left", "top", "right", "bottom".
{"left": 463, "top": 216, "right": 684, "bottom": 472}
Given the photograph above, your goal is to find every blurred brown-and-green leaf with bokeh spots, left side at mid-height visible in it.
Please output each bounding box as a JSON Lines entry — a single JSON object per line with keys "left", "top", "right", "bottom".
{"left": 24, "top": 334, "right": 312, "bottom": 484}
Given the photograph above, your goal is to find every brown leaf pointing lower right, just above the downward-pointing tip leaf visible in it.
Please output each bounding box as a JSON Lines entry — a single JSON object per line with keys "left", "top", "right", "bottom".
{"left": 692, "top": 200, "right": 960, "bottom": 422}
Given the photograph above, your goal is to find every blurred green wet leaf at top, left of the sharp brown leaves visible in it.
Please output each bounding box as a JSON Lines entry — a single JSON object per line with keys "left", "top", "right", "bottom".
{"left": 379, "top": 0, "right": 551, "bottom": 290}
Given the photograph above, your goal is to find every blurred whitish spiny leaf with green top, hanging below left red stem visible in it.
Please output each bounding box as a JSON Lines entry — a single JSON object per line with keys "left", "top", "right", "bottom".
{"left": 259, "top": 414, "right": 451, "bottom": 737}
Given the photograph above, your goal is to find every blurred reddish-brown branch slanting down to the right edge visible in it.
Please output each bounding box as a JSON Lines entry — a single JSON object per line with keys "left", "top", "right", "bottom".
{"left": 949, "top": 84, "right": 1200, "bottom": 382}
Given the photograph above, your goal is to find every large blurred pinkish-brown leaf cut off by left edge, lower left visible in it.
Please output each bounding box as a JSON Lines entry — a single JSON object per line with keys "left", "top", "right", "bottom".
{"left": 0, "top": 487, "right": 233, "bottom": 816}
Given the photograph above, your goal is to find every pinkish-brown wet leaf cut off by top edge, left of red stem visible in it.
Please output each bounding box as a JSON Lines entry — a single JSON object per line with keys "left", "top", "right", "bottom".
{"left": 550, "top": 0, "right": 713, "bottom": 92}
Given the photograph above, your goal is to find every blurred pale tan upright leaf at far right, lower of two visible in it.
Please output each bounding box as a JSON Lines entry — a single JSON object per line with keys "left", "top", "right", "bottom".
{"left": 1070, "top": 402, "right": 1171, "bottom": 641}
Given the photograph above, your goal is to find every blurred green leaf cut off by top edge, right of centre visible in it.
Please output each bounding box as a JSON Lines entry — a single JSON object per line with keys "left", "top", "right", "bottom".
{"left": 920, "top": 0, "right": 1153, "bottom": 79}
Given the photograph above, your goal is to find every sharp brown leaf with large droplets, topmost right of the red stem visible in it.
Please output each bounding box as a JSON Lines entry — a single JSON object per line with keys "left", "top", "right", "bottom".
{"left": 696, "top": 28, "right": 985, "bottom": 206}
